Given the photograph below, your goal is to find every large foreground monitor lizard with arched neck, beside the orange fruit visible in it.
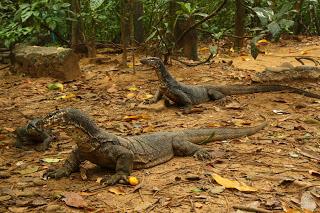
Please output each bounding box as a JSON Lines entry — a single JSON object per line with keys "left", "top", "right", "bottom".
{"left": 26, "top": 108, "right": 267, "bottom": 185}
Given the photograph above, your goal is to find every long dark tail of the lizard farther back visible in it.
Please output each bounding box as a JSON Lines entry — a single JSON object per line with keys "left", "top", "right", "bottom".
{"left": 213, "top": 85, "right": 320, "bottom": 99}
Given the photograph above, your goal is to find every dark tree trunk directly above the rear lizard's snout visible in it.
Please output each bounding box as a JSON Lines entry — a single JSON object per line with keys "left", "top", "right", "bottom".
{"left": 133, "top": 0, "right": 144, "bottom": 43}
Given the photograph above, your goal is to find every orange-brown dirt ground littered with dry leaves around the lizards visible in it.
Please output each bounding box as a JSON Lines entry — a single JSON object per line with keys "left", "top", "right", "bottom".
{"left": 0, "top": 37, "right": 320, "bottom": 213}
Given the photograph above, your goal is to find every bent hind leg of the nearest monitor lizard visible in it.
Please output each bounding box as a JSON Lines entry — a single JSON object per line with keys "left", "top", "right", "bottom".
{"left": 172, "top": 141, "right": 212, "bottom": 160}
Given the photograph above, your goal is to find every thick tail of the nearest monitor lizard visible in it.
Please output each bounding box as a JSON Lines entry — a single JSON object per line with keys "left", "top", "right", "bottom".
{"left": 182, "top": 118, "right": 268, "bottom": 144}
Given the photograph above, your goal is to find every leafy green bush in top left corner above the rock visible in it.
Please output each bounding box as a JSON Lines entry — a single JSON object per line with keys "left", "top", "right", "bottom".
{"left": 0, "top": 0, "right": 70, "bottom": 47}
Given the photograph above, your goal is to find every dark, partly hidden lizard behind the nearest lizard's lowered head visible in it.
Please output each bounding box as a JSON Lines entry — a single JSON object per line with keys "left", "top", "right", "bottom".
{"left": 15, "top": 119, "right": 54, "bottom": 151}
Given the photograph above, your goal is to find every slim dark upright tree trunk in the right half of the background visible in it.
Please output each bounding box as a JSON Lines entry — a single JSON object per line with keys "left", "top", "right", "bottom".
{"left": 233, "top": 0, "right": 246, "bottom": 51}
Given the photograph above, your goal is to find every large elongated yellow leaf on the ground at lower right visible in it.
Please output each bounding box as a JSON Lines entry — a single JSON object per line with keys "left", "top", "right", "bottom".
{"left": 211, "top": 173, "right": 257, "bottom": 192}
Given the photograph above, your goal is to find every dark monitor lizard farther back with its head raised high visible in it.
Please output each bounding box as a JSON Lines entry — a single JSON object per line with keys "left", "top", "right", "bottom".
{"left": 140, "top": 57, "right": 320, "bottom": 111}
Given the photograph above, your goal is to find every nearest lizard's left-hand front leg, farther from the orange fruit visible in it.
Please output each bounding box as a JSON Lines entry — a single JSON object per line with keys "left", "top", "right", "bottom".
{"left": 43, "top": 148, "right": 82, "bottom": 179}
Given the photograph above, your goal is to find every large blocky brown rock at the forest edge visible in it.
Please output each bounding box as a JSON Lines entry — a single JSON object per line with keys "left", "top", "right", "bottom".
{"left": 13, "top": 45, "right": 81, "bottom": 81}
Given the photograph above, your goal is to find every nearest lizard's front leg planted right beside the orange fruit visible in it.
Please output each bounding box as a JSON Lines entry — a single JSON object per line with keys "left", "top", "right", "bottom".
{"left": 100, "top": 145, "right": 133, "bottom": 185}
